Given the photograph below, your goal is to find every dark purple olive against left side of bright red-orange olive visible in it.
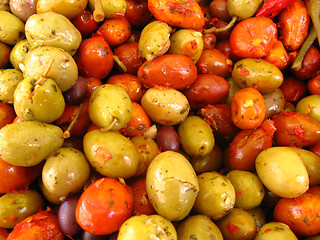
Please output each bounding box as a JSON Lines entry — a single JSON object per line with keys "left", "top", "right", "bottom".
{"left": 57, "top": 195, "right": 81, "bottom": 236}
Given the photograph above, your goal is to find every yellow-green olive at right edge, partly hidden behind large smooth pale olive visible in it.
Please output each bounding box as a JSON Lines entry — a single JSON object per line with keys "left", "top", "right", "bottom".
{"left": 290, "top": 147, "right": 320, "bottom": 186}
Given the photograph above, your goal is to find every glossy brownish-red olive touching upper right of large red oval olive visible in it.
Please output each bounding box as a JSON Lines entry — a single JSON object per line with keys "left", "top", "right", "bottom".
{"left": 196, "top": 49, "right": 233, "bottom": 78}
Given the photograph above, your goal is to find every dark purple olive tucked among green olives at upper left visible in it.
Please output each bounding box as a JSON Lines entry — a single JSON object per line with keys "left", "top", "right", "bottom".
{"left": 63, "top": 76, "right": 88, "bottom": 105}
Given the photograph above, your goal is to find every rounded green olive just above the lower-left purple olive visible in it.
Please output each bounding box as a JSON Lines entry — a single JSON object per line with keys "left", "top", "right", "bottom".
{"left": 42, "top": 147, "right": 90, "bottom": 197}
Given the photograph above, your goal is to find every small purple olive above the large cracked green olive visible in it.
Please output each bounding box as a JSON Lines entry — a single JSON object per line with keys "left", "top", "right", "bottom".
{"left": 156, "top": 126, "right": 180, "bottom": 152}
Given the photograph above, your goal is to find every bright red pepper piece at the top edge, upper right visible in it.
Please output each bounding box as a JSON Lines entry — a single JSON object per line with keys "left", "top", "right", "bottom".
{"left": 256, "top": 0, "right": 294, "bottom": 18}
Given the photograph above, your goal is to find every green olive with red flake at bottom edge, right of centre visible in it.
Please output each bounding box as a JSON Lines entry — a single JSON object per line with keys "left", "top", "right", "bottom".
{"left": 217, "top": 208, "right": 257, "bottom": 240}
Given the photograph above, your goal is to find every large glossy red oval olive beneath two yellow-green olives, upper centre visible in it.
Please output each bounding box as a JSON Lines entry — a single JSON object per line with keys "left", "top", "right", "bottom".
{"left": 137, "top": 54, "right": 197, "bottom": 90}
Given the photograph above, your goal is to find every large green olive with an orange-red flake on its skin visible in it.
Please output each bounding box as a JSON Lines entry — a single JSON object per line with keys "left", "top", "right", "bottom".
{"left": 83, "top": 129, "right": 140, "bottom": 178}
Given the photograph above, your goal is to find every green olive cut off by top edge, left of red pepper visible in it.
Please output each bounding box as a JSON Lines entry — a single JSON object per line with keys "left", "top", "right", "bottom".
{"left": 227, "top": 0, "right": 264, "bottom": 19}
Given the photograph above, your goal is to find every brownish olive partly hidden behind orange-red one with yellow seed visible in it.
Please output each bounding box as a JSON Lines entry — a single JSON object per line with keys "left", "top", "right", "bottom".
{"left": 262, "top": 88, "right": 286, "bottom": 119}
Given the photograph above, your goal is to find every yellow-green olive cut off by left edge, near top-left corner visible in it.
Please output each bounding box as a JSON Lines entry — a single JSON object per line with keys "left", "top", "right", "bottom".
{"left": 0, "top": 10, "right": 25, "bottom": 45}
